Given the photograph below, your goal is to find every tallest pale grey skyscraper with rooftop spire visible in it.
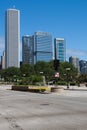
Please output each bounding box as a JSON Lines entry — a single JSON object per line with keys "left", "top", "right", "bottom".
{"left": 5, "top": 9, "right": 20, "bottom": 68}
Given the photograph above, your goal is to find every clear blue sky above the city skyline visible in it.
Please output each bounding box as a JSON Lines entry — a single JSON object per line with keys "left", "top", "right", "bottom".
{"left": 0, "top": 0, "right": 87, "bottom": 60}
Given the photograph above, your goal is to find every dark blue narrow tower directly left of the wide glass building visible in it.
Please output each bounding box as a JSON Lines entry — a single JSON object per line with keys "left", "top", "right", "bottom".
{"left": 22, "top": 35, "right": 34, "bottom": 64}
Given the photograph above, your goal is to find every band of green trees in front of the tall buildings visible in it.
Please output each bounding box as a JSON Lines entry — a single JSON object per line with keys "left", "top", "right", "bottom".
{"left": 0, "top": 61, "right": 80, "bottom": 84}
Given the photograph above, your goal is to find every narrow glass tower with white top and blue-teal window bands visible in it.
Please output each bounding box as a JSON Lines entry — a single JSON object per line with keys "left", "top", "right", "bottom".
{"left": 54, "top": 38, "right": 66, "bottom": 62}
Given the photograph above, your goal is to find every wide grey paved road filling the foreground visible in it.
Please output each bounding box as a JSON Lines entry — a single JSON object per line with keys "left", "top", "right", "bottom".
{"left": 0, "top": 85, "right": 87, "bottom": 130}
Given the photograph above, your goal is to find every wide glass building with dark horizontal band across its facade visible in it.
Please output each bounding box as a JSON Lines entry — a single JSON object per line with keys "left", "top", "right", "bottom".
{"left": 34, "top": 32, "right": 53, "bottom": 64}
